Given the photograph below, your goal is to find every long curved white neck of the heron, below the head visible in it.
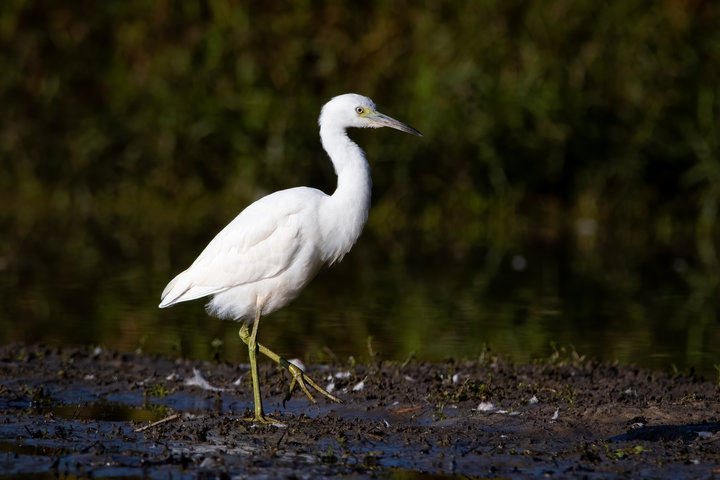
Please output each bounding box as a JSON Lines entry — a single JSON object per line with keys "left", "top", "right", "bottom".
{"left": 320, "top": 126, "right": 372, "bottom": 263}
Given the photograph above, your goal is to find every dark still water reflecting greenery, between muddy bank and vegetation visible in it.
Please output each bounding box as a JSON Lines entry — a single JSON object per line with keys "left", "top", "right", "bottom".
{"left": 0, "top": 236, "right": 720, "bottom": 378}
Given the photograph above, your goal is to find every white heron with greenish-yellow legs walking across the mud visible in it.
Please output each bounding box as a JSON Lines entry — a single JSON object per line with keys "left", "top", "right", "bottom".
{"left": 159, "top": 93, "right": 422, "bottom": 423}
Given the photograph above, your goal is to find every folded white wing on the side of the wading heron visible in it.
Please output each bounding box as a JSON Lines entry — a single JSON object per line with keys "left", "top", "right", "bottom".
{"left": 160, "top": 189, "right": 318, "bottom": 307}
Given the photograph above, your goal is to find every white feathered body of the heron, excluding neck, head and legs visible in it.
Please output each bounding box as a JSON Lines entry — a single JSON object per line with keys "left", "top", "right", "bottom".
{"left": 160, "top": 187, "right": 327, "bottom": 319}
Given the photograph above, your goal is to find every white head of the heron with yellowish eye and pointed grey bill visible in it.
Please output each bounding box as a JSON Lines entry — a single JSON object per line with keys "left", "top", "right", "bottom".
{"left": 318, "top": 93, "right": 422, "bottom": 136}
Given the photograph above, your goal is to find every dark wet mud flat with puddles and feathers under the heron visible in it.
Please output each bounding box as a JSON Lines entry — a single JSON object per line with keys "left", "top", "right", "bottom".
{"left": 0, "top": 345, "right": 720, "bottom": 479}
